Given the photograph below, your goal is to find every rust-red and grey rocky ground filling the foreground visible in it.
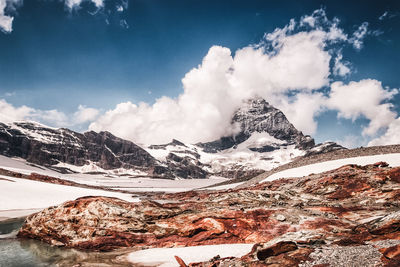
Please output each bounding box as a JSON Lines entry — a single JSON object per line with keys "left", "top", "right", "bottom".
{"left": 18, "top": 162, "right": 400, "bottom": 266}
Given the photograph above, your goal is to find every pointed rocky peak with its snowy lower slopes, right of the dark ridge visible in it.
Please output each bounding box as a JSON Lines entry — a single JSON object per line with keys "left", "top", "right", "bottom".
{"left": 146, "top": 98, "right": 344, "bottom": 178}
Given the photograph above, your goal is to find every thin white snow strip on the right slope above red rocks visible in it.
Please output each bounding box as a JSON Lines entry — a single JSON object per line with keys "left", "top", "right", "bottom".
{"left": 261, "top": 153, "right": 400, "bottom": 183}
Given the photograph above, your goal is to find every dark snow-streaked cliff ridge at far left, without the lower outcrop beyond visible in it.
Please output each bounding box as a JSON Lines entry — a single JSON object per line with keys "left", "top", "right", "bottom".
{"left": 0, "top": 122, "right": 156, "bottom": 169}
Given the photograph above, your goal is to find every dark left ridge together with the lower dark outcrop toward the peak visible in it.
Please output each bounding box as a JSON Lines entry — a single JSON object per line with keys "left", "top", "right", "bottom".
{"left": 0, "top": 122, "right": 208, "bottom": 178}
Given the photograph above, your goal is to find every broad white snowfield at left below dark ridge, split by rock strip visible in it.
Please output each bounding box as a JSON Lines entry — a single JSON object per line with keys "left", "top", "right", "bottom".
{"left": 0, "top": 156, "right": 226, "bottom": 219}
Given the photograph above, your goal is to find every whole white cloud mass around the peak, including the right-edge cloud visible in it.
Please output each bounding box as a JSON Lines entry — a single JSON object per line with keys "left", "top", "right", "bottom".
{"left": 89, "top": 9, "right": 397, "bottom": 144}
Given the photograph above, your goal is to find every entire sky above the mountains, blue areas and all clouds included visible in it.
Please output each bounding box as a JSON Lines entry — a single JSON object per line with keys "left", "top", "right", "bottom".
{"left": 0, "top": 0, "right": 400, "bottom": 147}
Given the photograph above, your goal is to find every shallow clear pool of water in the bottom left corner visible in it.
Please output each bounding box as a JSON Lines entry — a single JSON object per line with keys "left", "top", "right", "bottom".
{"left": 0, "top": 219, "right": 132, "bottom": 267}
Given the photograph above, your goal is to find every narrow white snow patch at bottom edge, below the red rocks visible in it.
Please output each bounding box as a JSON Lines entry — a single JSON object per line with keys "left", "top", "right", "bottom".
{"left": 128, "top": 244, "right": 253, "bottom": 267}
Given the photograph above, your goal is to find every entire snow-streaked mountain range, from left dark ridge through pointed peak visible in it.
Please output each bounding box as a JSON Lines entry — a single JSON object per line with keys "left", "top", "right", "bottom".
{"left": 0, "top": 98, "right": 342, "bottom": 178}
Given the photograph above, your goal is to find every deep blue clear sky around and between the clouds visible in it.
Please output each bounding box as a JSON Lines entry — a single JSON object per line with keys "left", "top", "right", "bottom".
{"left": 0, "top": 0, "right": 400, "bottom": 145}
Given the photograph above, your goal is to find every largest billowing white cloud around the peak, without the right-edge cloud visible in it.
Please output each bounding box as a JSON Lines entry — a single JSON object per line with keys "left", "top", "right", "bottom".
{"left": 89, "top": 9, "right": 354, "bottom": 144}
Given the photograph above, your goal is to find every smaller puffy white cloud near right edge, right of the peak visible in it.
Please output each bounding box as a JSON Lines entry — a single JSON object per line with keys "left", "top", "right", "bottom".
{"left": 327, "top": 79, "right": 398, "bottom": 136}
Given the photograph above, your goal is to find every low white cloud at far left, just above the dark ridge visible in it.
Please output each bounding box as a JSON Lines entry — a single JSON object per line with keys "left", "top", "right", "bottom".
{"left": 0, "top": 99, "right": 99, "bottom": 127}
